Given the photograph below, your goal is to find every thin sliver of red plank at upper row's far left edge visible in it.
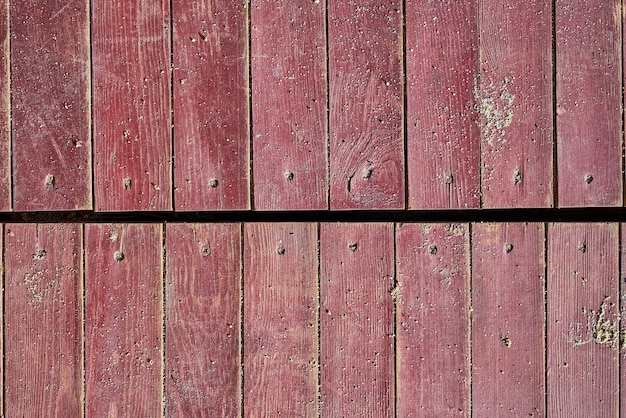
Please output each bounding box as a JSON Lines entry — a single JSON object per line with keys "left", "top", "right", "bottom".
{"left": 0, "top": 0, "right": 11, "bottom": 212}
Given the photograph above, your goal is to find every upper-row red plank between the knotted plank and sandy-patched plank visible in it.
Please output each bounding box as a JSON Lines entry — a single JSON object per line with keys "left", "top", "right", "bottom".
{"left": 405, "top": 0, "right": 480, "bottom": 209}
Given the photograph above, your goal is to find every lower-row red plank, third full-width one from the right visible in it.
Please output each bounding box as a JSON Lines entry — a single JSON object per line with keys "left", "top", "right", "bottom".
{"left": 394, "top": 224, "right": 471, "bottom": 417}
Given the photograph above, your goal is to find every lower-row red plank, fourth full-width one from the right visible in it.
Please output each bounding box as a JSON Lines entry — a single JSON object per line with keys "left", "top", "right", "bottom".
{"left": 320, "top": 223, "right": 395, "bottom": 417}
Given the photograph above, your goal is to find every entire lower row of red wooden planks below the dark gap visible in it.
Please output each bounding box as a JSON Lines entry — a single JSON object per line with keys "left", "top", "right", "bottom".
{"left": 2, "top": 223, "right": 626, "bottom": 417}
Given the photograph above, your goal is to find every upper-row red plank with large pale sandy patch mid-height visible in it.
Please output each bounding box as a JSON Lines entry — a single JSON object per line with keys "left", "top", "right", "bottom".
{"left": 476, "top": 0, "right": 552, "bottom": 208}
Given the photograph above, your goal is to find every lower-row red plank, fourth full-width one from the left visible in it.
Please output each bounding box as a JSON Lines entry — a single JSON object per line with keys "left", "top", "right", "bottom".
{"left": 243, "top": 223, "right": 319, "bottom": 416}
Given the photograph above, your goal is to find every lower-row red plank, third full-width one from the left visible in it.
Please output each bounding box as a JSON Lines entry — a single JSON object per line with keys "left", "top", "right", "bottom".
{"left": 165, "top": 224, "right": 241, "bottom": 417}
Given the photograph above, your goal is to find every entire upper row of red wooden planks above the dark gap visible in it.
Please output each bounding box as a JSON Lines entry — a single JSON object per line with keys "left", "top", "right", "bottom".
{"left": 0, "top": 0, "right": 624, "bottom": 212}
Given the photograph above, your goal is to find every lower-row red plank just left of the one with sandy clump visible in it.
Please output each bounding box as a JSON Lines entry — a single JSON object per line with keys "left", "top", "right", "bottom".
{"left": 472, "top": 223, "right": 546, "bottom": 417}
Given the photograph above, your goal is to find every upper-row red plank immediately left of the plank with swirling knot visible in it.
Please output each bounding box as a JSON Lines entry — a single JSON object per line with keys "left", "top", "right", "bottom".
{"left": 251, "top": 0, "right": 328, "bottom": 210}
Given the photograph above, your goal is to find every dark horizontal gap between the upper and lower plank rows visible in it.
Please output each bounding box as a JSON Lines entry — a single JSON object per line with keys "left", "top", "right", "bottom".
{"left": 0, "top": 208, "right": 626, "bottom": 223}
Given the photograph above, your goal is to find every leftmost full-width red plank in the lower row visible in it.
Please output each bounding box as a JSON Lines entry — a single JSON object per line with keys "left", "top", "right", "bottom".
{"left": 4, "top": 224, "right": 83, "bottom": 417}
